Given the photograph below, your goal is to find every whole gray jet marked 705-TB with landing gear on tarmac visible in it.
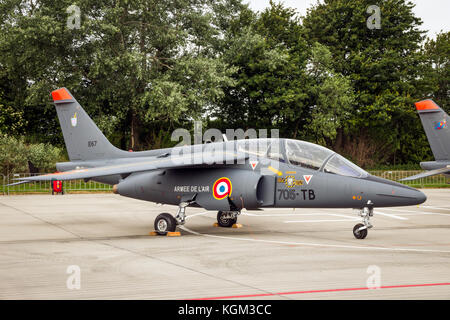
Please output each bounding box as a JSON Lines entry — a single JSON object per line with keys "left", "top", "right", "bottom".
{"left": 14, "top": 88, "right": 426, "bottom": 239}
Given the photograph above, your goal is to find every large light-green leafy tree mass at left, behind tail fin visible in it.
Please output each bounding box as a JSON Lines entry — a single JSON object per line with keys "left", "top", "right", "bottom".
{"left": 0, "top": 0, "right": 239, "bottom": 149}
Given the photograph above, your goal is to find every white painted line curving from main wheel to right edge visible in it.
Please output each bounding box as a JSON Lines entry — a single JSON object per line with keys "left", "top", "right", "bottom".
{"left": 179, "top": 226, "right": 450, "bottom": 253}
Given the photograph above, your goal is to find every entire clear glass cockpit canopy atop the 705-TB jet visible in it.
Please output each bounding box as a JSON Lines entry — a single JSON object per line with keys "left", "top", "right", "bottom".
{"left": 237, "top": 139, "right": 368, "bottom": 178}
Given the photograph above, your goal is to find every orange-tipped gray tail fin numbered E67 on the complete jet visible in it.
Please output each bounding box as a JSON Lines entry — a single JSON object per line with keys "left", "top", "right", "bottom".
{"left": 52, "top": 88, "right": 128, "bottom": 161}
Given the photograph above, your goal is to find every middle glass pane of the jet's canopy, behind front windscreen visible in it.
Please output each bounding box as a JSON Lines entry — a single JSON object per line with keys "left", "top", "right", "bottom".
{"left": 286, "top": 140, "right": 333, "bottom": 170}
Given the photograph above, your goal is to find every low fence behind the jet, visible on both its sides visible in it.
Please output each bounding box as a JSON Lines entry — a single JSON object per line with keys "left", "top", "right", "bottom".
{"left": 0, "top": 170, "right": 450, "bottom": 195}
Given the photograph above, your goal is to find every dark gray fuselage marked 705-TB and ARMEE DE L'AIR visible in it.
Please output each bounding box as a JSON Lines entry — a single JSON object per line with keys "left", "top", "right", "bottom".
{"left": 57, "top": 139, "right": 426, "bottom": 210}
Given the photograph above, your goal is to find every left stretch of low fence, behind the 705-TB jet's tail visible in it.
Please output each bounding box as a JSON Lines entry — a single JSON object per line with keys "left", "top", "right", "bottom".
{"left": 0, "top": 173, "right": 112, "bottom": 195}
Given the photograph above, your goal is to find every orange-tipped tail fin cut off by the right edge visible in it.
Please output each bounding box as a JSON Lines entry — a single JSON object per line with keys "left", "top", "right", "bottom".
{"left": 415, "top": 99, "right": 450, "bottom": 160}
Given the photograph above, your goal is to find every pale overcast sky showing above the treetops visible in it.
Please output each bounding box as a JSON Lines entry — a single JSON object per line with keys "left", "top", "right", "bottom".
{"left": 248, "top": 0, "right": 450, "bottom": 38}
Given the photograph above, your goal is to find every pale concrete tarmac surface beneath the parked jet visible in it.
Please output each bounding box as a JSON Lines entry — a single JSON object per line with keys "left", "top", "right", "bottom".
{"left": 0, "top": 189, "right": 450, "bottom": 299}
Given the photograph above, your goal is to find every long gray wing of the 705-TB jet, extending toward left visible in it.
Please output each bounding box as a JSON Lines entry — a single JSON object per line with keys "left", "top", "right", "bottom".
{"left": 11, "top": 151, "right": 248, "bottom": 184}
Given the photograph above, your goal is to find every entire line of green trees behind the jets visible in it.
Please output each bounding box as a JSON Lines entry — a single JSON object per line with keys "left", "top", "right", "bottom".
{"left": 0, "top": 0, "right": 450, "bottom": 174}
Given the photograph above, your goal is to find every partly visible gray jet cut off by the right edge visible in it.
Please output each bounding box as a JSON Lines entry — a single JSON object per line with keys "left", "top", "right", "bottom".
{"left": 402, "top": 99, "right": 450, "bottom": 181}
